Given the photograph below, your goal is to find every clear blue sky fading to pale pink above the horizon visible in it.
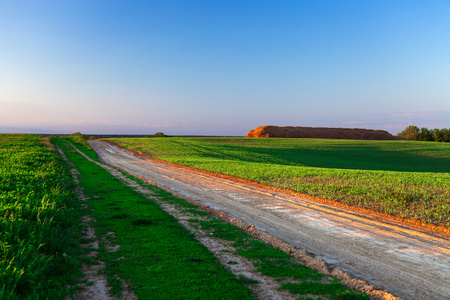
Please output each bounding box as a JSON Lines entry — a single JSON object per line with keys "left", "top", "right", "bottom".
{"left": 0, "top": 0, "right": 450, "bottom": 136}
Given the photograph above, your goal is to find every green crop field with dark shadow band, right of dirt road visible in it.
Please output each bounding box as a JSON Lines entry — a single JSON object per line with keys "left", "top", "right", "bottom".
{"left": 110, "top": 137, "right": 450, "bottom": 226}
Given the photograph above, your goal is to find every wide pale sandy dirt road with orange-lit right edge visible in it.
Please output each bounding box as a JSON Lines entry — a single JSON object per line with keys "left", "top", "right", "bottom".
{"left": 90, "top": 141, "right": 450, "bottom": 300}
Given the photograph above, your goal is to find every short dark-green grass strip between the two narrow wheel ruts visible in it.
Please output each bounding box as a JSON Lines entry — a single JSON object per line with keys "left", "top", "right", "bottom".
{"left": 53, "top": 140, "right": 252, "bottom": 299}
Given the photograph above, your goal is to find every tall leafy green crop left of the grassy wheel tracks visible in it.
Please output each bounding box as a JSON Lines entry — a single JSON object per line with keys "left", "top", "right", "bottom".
{"left": 0, "top": 134, "right": 81, "bottom": 299}
